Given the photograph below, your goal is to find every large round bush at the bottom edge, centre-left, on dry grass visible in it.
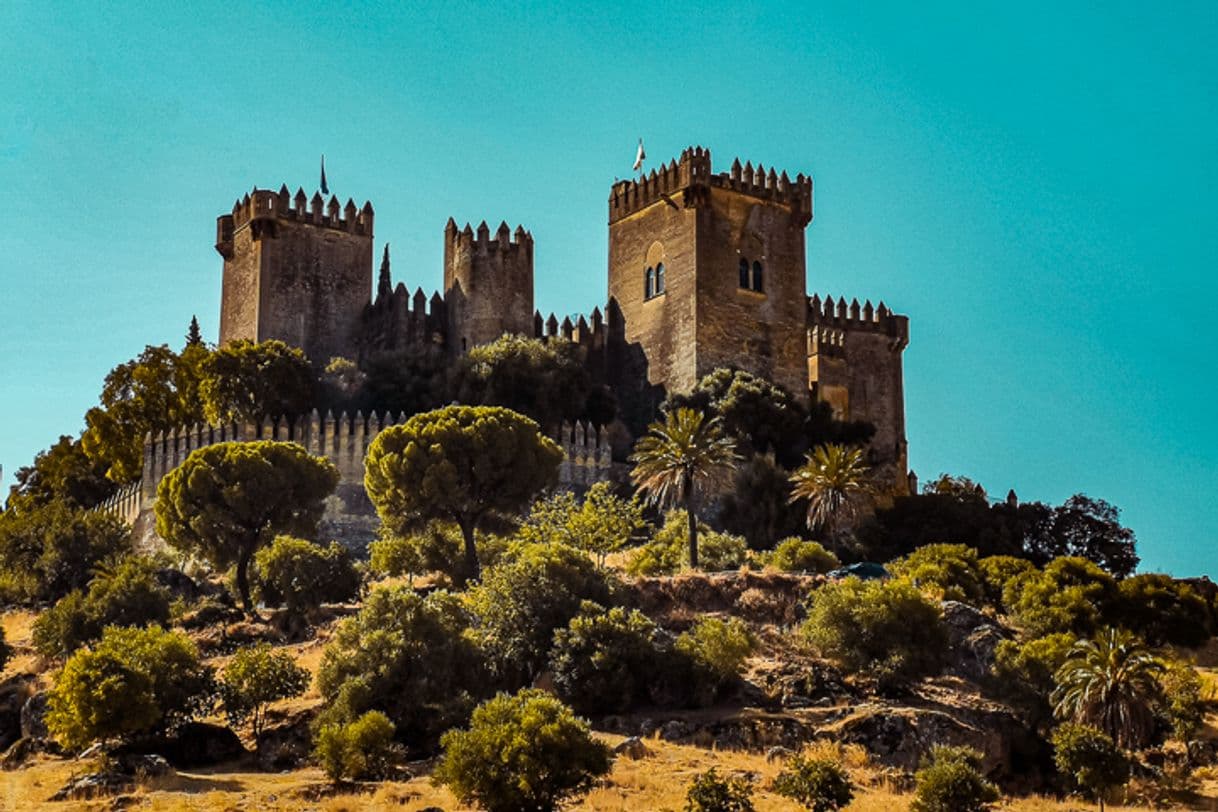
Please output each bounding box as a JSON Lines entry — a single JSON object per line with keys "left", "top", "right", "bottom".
{"left": 434, "top": 690, "right": 613, "bottom": 812}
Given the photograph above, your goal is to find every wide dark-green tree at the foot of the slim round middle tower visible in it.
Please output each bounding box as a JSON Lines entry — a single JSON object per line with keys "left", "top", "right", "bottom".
{"left": 452, "top": 335, "right": 614, "bottom": 431}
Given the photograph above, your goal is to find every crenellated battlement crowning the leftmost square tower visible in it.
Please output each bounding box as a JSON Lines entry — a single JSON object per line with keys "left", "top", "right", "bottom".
{"left": 216, "top": 185, "right": 374, "bottom": 259}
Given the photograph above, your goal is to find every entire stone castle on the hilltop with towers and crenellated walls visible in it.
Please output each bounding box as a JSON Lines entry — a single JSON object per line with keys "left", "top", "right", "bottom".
{"left": 102, "top": 147, "right": 909, "bottom": 550}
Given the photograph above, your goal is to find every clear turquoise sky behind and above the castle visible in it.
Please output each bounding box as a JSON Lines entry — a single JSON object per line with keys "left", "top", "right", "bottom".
{"left": 0, "top": 0, "right": 1218, "bottom": 575}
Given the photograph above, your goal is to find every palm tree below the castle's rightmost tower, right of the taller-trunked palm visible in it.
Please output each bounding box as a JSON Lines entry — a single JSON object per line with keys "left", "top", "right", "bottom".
{"left": 790, "top": 443, "right": 871, "bottom": 551}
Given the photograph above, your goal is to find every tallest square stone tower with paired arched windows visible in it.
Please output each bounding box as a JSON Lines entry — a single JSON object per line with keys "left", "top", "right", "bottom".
{"left": 609, "top": 147, "right": 812, "bottom": 397}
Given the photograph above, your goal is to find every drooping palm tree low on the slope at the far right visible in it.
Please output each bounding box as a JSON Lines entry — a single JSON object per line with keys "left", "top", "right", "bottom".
{"left": 1050, "top": 628, "right": 1163, "bottom": 747}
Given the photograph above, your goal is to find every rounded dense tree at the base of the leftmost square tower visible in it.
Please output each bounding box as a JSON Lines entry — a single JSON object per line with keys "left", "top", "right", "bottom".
{"left": 199, "top": 338, "right": 314, "bottom": 424}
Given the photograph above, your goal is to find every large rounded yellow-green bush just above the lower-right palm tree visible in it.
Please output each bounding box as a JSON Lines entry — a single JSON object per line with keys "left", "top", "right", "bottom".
{"left": 1002, "top": 558, "right": 1118, "bottom": 637}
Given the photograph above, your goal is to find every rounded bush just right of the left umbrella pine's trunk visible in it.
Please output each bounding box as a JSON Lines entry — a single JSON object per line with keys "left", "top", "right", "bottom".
{"left": 255, "top": 536, "right": 359, "bottom": 615}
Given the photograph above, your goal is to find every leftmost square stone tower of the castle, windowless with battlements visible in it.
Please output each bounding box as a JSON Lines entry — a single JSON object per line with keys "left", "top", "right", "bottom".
{"left": 216, "top": 186, "right": 373, "bottom": 366}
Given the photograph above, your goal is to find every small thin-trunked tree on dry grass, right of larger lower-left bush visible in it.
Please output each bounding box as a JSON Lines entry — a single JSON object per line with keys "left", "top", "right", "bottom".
{"left": 219, "top": 643, "right": 309, "bottom": 747}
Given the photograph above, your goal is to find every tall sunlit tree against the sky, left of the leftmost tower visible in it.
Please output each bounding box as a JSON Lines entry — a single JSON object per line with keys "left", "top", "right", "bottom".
{"left": 80, "top": 343, "right": 209, "bottom": 483}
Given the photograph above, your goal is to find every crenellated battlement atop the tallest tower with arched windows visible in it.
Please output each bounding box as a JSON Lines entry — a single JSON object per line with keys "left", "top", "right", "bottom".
{"left": 609, "top": 146, "right": 812, "bottom": 225}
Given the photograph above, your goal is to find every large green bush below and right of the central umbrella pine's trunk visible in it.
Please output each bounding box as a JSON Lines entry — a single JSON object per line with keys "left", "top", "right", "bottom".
{"left": 468, "top": 544, "right": 610, "bottom": 687}
